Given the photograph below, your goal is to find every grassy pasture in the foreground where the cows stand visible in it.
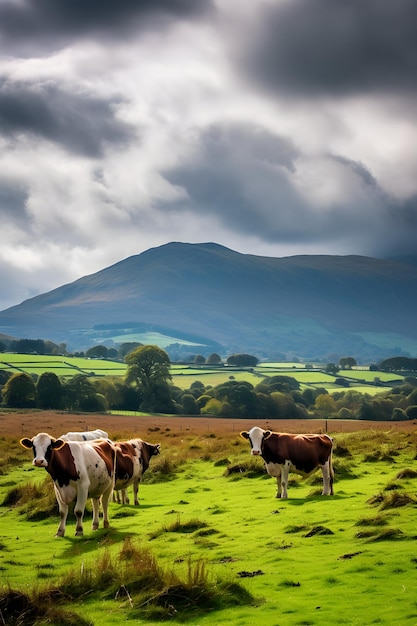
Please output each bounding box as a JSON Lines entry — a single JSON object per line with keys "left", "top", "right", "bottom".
{"left": 0, "top": 412, "right": 417, "bottom": 626}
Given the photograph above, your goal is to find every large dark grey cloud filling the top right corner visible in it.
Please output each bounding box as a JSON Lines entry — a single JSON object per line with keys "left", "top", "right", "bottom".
{"left": 237, "top": 0, "right": 417, "bottom": 96}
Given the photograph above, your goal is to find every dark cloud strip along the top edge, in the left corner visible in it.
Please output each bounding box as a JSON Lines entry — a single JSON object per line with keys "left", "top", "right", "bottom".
{"left": 0, "top": 0, "right": 213, "bottom": 54}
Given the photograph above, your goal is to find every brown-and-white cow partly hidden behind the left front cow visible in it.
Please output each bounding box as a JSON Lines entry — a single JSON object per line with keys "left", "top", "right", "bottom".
{"left": 114, "top": 439, "right": 161, "bottom": 505}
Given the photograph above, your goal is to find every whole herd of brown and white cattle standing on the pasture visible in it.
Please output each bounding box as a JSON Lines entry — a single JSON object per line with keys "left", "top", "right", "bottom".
{"left": 20, "top": 426, "right": 334, "bottom": 537}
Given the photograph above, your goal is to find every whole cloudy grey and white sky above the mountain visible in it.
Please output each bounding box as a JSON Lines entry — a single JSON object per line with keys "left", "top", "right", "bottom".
{"left": 0, "top": 0, "right": 417, "bottom": 310}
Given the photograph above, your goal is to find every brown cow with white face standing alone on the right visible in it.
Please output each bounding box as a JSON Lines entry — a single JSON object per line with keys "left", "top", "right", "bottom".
{"left": 240, "top": 426, "right": 334, "bottom": 498}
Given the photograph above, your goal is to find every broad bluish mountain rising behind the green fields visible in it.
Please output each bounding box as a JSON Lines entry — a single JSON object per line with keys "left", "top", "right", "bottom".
{"left": 0, "top": 242, "right": 417, "bottom": 361}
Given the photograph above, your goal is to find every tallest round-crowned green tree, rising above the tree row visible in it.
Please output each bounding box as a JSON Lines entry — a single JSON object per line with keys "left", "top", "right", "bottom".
{"left": 125, "top": 345, "right": 172, "bottom": 411}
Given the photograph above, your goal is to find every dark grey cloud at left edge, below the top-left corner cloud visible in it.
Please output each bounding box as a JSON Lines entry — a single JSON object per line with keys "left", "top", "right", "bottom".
{"left": 0, "top": 81, "right": 134, "bottom": 157}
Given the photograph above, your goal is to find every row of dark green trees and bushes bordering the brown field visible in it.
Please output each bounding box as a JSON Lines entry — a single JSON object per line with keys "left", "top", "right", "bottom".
{"left": 0, "top": 346, "right": 417, "bottom": 420}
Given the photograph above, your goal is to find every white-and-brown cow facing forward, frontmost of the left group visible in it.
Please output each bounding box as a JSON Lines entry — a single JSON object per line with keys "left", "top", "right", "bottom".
{"left": 20, "top": 433, "right": 116, "bottom": 537}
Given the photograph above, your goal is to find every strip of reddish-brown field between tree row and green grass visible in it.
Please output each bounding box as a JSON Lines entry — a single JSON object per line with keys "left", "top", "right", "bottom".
{"left": 0, "top": 411, "right": 417, "bottom": 439}
